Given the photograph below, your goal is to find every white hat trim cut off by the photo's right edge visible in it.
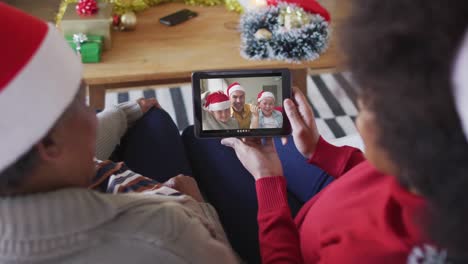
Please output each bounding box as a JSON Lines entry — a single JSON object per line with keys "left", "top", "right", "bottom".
{"left": 453, "top": 31, "right": 468, "bottom": 140}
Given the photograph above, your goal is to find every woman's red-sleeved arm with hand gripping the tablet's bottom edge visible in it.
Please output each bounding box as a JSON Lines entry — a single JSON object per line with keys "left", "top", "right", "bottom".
{"left": 221, "top": 138, "right": 302, "bottom": 263}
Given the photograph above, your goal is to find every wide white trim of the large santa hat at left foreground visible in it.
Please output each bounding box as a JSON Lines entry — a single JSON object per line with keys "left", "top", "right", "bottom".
{"left": 0, "top": 24, "right": 82, "bottom": 171}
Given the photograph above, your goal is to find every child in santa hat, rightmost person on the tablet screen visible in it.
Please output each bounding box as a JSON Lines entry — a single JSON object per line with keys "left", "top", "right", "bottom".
{"left": 251, "top": 91, "right": 283, "bottom": 128}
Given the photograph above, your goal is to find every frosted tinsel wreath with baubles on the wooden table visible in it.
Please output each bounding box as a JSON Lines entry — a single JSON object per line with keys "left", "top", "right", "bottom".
{"left": 240, "top": 3, "right": 330, "bottom": 62}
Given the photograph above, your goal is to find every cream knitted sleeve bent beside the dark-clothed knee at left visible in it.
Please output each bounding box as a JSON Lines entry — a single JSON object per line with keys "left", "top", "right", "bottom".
{"left": 96, "top": 102, "right": 143, "bottom": 160}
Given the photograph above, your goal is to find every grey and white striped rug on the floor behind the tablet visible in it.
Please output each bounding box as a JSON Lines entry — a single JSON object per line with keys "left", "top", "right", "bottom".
{"left": 106, "top": 72, "right": 358, "bottom": 140}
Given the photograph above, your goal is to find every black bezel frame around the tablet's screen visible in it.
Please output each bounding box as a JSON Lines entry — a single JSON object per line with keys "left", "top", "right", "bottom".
{"left": 192, "top": 69, "right": 292, "bottom": 138}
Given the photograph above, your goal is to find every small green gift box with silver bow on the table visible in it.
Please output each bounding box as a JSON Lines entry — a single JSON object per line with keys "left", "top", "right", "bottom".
{"left": 65, "top": 34, "right": 104, "bottom": 63}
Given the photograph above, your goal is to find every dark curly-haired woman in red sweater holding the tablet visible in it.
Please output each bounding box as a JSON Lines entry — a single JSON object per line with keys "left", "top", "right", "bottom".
{"left": 218, "top": 0, "right": 468, "bottom": 263}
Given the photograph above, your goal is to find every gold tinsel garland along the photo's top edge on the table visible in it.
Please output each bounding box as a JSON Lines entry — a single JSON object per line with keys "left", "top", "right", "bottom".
{"left": 55, "top": 0, "right": 243, "bottom": 25}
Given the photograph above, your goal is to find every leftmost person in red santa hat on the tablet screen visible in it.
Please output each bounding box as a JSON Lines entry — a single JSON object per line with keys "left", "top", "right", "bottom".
{"left": 202, "top": 91, "right": 239, "bottom": 130}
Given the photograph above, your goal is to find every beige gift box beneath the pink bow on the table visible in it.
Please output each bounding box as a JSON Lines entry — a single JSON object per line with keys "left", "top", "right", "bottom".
{"left": 59, "top": 3, "right": 112, "bottom": 50}
